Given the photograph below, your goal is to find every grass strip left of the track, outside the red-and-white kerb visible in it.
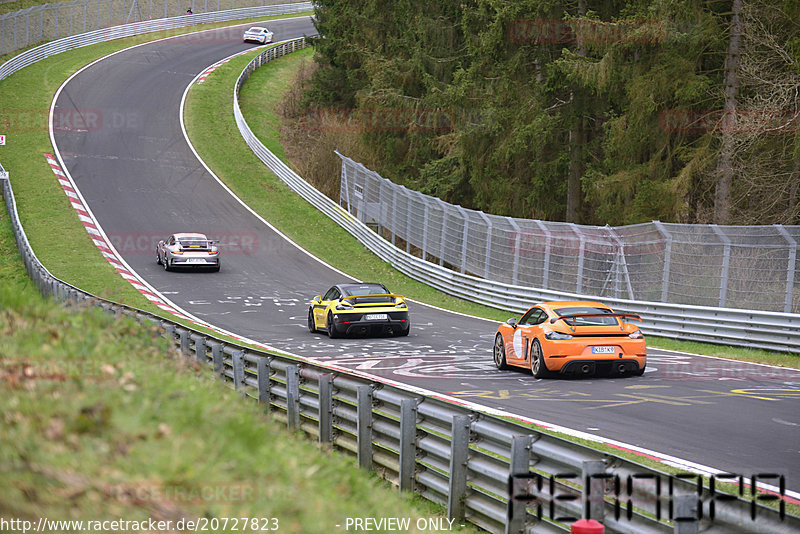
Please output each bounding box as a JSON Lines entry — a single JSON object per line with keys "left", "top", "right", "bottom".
{"left": 0, "top": 13, "right": 318, "bottom": 348}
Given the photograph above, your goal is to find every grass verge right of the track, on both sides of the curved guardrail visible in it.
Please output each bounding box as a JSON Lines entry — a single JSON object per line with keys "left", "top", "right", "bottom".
{"left": 186, "top": 49, "right": 800, "bottom": 368}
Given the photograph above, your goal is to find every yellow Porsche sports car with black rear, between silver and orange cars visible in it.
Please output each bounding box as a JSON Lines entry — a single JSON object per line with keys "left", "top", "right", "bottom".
{"left": 308, "top": 283, "right": 411, "bottom": 338}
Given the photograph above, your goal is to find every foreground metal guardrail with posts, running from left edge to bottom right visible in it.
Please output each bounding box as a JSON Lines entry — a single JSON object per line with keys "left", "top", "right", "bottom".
{"left": 0, "top": 173, "right": 800, "bottom": 534}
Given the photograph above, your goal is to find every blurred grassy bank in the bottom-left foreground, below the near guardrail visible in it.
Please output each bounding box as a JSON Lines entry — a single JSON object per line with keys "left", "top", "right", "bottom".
{"left": 0, "top": 210, "right": 482, "bottom": 533}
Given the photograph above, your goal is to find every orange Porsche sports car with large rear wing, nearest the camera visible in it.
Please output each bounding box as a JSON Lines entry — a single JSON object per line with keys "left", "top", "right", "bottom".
{"left": 494, "top": 301, "right": 647, "bottom": 378}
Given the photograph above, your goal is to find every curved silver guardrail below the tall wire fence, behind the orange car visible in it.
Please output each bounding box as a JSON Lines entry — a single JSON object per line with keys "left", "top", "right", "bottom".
{"left": 233, "top": 43, "right": 800, "bottom": 353}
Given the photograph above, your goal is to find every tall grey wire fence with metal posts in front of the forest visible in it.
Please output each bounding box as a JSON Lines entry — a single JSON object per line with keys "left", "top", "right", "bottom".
{"left": 339, "top": 154, "right": 800, "bottom": 313}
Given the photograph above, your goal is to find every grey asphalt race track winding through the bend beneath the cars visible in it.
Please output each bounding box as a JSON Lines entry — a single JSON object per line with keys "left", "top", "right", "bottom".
{"left": 48, "top": 18, "right": 800, "bottom": 490}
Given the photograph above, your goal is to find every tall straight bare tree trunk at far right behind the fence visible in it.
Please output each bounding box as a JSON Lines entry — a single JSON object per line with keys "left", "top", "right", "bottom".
{"left": 714, "top": 0, "right": 742, "bottom": 224}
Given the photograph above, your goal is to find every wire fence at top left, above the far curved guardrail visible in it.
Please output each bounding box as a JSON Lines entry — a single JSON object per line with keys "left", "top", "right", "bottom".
{"left": 0, "top": 0, "right": 300, "bottom": 56}
